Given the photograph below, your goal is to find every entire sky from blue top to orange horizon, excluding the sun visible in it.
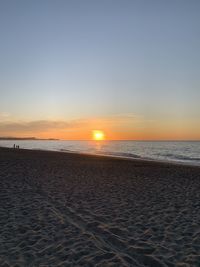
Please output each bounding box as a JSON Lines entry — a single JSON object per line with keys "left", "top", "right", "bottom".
{"left": 0, "top": 0, "right": 200, "bottom": 140}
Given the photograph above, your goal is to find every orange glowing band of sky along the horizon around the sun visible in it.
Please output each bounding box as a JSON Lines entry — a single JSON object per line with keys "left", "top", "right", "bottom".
{"left": 0, "top": 114, "right": 200, "bottom": 140}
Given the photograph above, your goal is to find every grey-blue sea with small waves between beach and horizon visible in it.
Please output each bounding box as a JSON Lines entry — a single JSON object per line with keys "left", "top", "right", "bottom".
{"left": 0, "top": 140, "right": 200, "bottom": 165}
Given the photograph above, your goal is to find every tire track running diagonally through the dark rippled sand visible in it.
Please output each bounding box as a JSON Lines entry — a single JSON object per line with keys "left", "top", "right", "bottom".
{"left": 32, "top": 188, "right": 167, "bottom": 267}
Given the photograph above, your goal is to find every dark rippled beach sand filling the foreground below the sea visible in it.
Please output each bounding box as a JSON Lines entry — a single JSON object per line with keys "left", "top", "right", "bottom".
{"left": 0, "top": 148, "right": 200, "bottom": 267}
